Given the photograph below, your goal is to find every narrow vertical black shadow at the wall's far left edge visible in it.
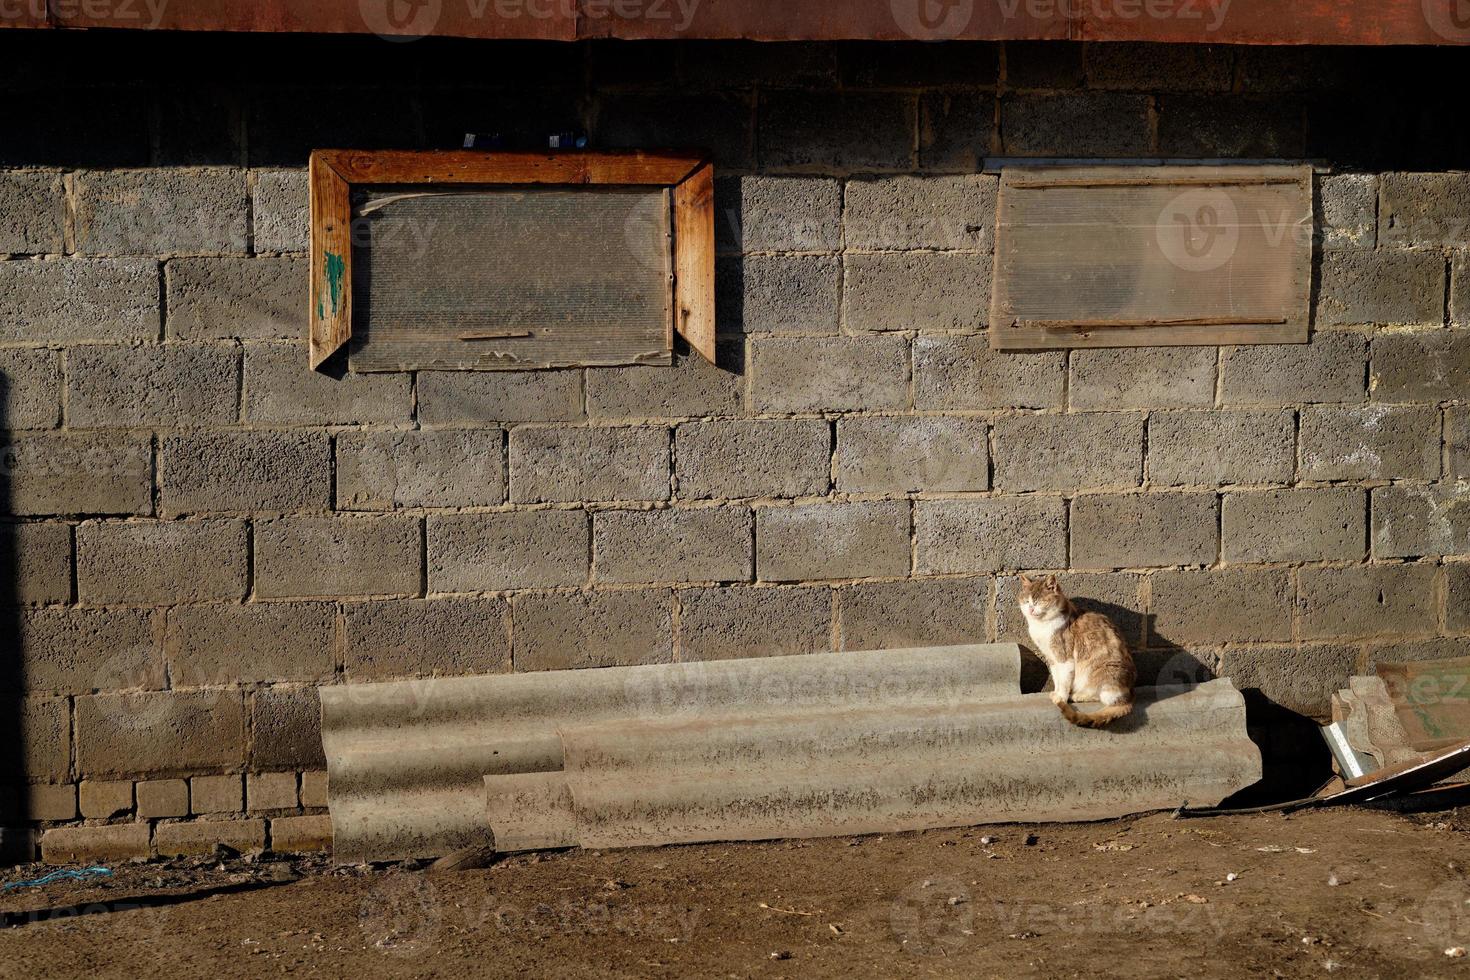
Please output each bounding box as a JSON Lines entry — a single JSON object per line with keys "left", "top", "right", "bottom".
{"left": 0, "top": 372, "right": 32, "bottom": 867}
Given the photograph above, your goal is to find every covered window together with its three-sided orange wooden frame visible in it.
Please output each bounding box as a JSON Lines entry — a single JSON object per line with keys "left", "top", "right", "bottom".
{"left": 310, "top": 150, "right": 714, "bottom": 372}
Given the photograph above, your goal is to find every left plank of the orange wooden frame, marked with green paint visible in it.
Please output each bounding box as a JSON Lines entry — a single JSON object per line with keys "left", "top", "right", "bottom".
{"left": 307, "top": 153, "right": 353, "bottom": 370}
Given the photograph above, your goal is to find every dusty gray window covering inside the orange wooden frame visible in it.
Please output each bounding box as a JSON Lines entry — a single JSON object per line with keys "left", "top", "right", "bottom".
{"left": 351, "top": 188, "right": 673, "bottom": 372}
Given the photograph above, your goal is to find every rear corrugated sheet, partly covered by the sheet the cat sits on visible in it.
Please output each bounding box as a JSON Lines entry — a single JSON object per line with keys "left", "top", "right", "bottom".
{"left": 320, "top": 644, "right": 1020, "bottom": 862}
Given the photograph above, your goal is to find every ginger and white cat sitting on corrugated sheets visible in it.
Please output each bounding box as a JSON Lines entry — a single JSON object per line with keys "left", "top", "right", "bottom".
{"left": 1017, "top": 574, "right": 1138, "bottom": 729}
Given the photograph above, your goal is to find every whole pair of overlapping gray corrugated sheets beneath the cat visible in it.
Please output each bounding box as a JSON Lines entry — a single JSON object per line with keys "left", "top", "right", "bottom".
{"left": 322, "top": 645, "right": 1261, "bottom": 861}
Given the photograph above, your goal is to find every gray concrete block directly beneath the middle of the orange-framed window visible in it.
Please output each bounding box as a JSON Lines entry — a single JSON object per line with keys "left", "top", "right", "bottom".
{"left": 419, "top": 367, "right": 582, "bottom": 425}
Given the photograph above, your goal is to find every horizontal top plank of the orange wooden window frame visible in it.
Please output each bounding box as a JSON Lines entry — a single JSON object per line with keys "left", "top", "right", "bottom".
{"left": 319, "top": 150, "right": 703, "bottom": 185}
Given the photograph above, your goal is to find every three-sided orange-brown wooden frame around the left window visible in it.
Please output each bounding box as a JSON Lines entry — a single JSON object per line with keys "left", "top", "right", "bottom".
{"left": 307, "top": 150, "right": 714, "bottom": 370}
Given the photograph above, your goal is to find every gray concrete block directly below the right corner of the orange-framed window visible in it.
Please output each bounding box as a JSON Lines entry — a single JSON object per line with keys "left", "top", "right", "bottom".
{"left": 585, "top": 344, "right": 745, "bottom": 420}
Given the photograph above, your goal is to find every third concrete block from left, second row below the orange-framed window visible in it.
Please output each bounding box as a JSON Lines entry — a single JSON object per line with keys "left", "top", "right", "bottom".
{"left": 337, "top": 429, "right": 506, "bottom": 510}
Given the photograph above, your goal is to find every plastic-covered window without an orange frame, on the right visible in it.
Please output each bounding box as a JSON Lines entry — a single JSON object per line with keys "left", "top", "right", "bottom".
{"left": 991, "top": 166, "right": 1313, "bottom": 348}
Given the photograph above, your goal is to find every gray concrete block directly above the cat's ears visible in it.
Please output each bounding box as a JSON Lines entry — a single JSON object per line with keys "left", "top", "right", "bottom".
{"left": 914, "top": 497, "right": 1067, "bottom": 574}
